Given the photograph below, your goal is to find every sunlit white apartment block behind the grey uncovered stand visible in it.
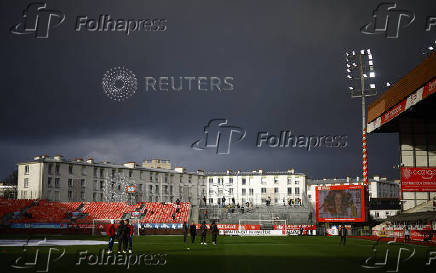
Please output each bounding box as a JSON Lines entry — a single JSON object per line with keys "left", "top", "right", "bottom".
{"left": 207, "top": 169, "right": 306, "bottom": 205}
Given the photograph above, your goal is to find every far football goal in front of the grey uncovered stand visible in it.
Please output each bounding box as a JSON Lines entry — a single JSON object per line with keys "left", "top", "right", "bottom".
{"left": 238, "top": 219, "right": 288, "bottom": 236}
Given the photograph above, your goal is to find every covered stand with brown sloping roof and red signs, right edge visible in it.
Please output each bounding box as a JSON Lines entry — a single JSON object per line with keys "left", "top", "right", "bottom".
{"left": 367, "top": 53, "right": 436, "bottom": 211}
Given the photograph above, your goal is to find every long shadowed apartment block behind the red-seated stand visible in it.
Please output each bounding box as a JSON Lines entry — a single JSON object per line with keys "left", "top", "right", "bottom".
{"left": 17, "top": 155, "right": 206, "bottom": 205}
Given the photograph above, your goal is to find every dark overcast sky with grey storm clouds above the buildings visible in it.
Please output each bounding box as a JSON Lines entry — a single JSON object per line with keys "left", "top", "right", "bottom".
{"left": 0, "top": 0, "right": 436, "bottom": 178}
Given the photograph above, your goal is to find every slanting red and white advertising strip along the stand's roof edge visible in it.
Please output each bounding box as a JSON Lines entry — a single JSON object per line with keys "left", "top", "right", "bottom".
{"left": 367, "top": 76, "right": 436, "bottom": 133}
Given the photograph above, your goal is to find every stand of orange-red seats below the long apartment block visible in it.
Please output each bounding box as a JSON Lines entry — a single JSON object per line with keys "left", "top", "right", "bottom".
{"left": 0, "top": 200, "right": 191, "bottom": 225}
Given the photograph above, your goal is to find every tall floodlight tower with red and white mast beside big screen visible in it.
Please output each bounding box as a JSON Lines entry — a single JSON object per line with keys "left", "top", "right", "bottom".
{"left": 345, "top": 49, "right": 377, "bottom": 185}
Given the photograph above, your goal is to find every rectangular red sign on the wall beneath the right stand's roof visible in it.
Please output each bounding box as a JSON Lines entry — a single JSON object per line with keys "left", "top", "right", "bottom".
{"left": 401, "top": 167, "right": 436, "bottom": 192}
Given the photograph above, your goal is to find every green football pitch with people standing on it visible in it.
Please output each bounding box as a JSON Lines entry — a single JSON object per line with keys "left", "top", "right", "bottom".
{"left": 0, "top": 235, "right": 436, "bottom": 273}
